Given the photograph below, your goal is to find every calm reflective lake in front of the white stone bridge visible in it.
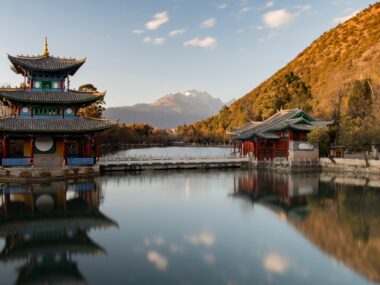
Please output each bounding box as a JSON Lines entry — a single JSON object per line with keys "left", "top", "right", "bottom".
{"left": 0, "top": 170, "right": 380, "bottom": 285}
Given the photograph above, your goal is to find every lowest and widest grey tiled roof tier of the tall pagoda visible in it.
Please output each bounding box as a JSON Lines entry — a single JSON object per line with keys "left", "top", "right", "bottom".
{"left": 0, "top": 116, "right": 115, "bottom": 133}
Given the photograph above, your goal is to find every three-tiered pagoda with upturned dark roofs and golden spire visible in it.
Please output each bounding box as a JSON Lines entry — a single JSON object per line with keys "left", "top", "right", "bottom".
{"left": 0, "top": 39, "right": 112, "bottom": 167}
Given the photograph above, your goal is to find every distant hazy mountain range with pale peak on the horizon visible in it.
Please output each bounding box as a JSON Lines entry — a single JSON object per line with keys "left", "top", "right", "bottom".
{"left": 103, "top": 90, "right": 229, "bottom": 129}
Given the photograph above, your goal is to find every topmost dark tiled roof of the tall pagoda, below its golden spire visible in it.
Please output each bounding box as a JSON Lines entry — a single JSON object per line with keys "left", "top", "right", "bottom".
{"left": 8, "top": 55, "right": 86, "bottom": 76}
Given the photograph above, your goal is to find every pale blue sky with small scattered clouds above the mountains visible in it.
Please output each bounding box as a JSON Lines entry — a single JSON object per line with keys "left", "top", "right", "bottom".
{"left": 0, "top": 0, "right": 376, "bottom": 107}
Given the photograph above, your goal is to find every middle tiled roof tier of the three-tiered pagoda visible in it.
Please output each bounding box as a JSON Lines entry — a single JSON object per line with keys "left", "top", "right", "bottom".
{"left": 0, "top": 88, "right": 105, "bottom": 104}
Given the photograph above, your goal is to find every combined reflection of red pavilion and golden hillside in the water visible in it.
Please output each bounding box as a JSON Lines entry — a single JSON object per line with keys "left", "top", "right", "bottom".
{"left": 233, "top": 171, "right": 380, "bottom": 282}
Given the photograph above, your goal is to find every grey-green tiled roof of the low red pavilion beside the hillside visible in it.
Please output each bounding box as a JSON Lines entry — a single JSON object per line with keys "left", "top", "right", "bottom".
{"left": 230, "top": 109, "right": 333, "bottom": 139}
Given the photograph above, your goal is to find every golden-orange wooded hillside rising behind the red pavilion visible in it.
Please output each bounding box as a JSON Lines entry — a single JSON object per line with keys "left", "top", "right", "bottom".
{"left": 191, "top": 3, "right": 380, "bottom": 148}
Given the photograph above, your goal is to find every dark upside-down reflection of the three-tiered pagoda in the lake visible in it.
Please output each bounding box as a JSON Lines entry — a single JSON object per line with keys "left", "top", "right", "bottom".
{"left": 0, "top": 181, "right": 117, "bottom": 284}
